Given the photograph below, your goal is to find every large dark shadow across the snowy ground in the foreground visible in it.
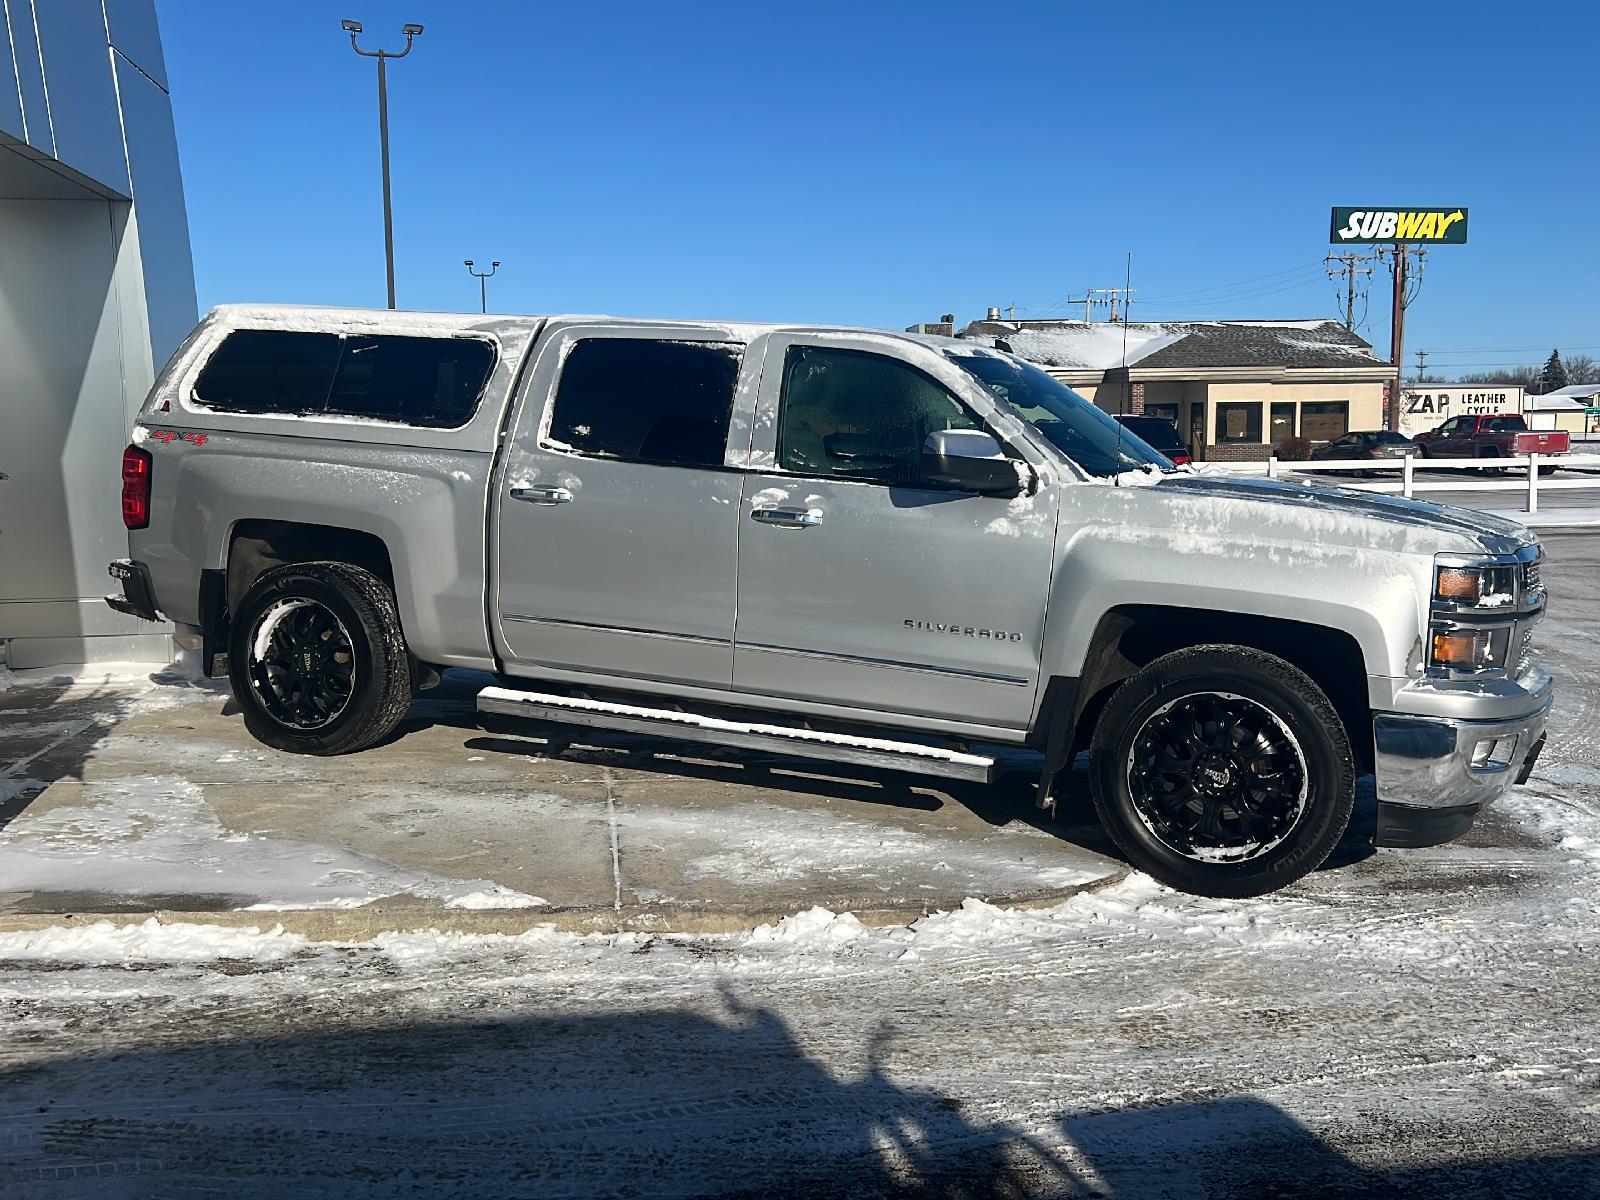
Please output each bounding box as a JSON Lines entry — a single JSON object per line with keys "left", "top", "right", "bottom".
{"left": 0, "top": 994, "right": 1600, "bottom": 1200}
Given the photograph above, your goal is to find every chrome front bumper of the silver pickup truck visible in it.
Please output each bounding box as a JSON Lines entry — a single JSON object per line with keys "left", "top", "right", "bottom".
{"left": 1373, "top": 686, "right": 1555, "bottom": 846}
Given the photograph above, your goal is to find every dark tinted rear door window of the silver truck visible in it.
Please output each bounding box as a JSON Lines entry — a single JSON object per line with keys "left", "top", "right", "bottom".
{"left": 546, "top": 338, "right": 742, "bottom": 467}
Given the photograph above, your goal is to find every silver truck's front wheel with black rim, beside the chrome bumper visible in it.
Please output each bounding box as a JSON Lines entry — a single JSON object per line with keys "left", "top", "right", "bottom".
{"left": 1090, "top": 646, "right": 1355, "bottom": 896}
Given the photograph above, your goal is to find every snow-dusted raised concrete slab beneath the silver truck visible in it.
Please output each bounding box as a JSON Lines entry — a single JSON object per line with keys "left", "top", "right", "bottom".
{"left": 0, "top": 672, "right": 1123, "bottom": 936}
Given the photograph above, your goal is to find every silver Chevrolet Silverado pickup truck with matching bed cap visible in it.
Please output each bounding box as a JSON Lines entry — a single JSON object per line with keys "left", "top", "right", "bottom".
{"left": 107, "top": 306, "right": 1552, "bottom": 896}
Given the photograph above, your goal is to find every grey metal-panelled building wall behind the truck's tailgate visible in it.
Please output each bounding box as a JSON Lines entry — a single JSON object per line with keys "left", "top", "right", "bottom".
{"left": 0, "top": 0, "right": 195, "bottom": 667}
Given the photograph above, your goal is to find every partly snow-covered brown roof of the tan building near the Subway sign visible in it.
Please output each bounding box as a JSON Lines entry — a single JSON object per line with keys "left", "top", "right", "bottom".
{"left": 960, "top": 320, "right": 1376, "bottom": 371}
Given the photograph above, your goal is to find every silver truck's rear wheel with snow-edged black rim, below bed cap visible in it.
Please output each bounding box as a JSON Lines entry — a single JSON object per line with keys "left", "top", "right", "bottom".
{"left": 227, "top": 563, "right": 411, "bottom": 755}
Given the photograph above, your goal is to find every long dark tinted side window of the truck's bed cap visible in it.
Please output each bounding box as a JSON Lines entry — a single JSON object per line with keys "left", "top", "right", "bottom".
{"left": 195, "top": 330, "right": 494, "bottom": 429}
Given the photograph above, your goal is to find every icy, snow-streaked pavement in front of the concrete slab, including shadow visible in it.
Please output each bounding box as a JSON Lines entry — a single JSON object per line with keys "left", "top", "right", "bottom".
{"left": 0, "top": 536, "right": 1600, "bottom": 1200}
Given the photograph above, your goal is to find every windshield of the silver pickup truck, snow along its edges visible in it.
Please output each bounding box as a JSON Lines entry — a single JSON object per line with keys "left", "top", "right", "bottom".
{"left": 946, "top": 350, "right": 1176, "bottom": 477}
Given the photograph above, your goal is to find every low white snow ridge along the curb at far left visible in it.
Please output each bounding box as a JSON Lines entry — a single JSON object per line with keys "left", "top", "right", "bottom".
{"left": 0, "top": 917, "right": 306, "bottom": 965}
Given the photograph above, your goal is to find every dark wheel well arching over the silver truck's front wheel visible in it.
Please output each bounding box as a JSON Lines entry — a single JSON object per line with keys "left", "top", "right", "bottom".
{"left": 1074, "top": 605, "right": 1373, "bottom": 771}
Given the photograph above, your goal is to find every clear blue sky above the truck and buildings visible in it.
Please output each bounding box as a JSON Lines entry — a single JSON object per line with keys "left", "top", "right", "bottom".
{"left": 158, "top": 0, "right": 1600, "bottom": 371}
